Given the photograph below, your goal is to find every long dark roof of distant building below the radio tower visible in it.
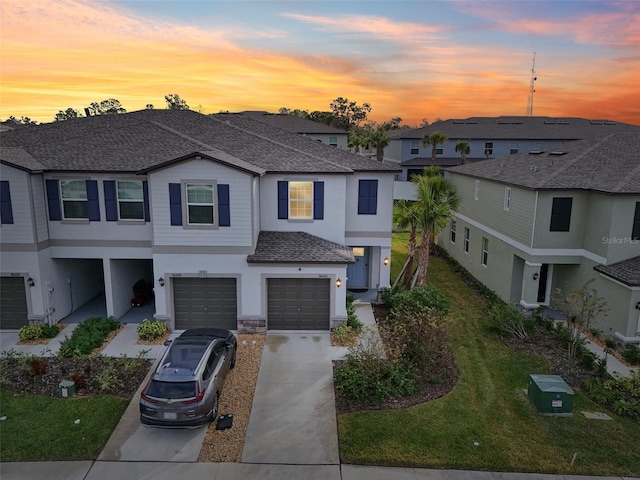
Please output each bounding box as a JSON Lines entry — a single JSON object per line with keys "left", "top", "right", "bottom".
{"left": 389, "top": 117, "right": 640, "bottom": 141}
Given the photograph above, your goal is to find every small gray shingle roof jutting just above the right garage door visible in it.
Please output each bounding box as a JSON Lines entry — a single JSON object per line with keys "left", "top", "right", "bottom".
{"left": 247, "top": 232, "right": 355, "bottom": 264}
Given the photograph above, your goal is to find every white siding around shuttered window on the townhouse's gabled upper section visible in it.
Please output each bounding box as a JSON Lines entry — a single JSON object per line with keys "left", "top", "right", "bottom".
{"left": 149, "top": 160, "right": 253, "bottom": 247}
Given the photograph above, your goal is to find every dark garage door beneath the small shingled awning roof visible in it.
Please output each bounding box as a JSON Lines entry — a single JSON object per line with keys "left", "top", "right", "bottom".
{"left": 267, "top": 278, "right": 330, "bottom": 330}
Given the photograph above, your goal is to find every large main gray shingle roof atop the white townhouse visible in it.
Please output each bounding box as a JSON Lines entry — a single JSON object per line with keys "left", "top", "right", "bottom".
{"left": 0, "top": 110, "right": 394, "bottom": 174}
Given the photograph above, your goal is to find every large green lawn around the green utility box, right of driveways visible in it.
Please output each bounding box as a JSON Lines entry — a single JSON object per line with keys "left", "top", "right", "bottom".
{"left": 338, "top": 235, "right": 640, "bottom": 476}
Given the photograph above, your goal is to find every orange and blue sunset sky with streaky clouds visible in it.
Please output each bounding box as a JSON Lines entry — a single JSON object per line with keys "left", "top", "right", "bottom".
{"left": 0, "top": 0, "right": 640, "bottom": 125}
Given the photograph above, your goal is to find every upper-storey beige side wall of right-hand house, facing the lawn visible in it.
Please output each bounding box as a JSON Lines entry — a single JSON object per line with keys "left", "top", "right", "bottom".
{"left": 449, "top": 173, "right": 536, "bottom": 246}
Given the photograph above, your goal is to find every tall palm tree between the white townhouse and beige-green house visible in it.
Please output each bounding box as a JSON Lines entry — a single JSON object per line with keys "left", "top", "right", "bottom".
{"left": 411, "top": 174, "right": 460, "bottom": 287}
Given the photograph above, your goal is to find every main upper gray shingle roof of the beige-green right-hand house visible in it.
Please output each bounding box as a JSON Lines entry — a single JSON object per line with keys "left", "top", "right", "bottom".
{"left": 449, "top": 133, "right": 640, "bottom": 194}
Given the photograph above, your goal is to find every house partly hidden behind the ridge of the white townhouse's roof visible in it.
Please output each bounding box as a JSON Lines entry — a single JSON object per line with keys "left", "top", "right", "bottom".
{"left": 228, "top": 110, "right": 349, "bottom": 150}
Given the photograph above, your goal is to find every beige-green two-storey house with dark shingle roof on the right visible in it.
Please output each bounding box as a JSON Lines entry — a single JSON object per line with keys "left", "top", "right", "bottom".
{"left": 439, "top": 133, "right": 640, "bottom": 342}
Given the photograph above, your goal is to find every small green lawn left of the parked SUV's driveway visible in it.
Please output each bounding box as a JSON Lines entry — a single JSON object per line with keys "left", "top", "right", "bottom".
{"left": 0, "top": 390, "right": 129, "bottom": 462}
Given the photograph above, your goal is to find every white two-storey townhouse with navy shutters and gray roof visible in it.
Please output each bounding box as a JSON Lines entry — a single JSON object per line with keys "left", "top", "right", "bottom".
{"left": 0, "top": 110, "right": 394, "bottom": 331}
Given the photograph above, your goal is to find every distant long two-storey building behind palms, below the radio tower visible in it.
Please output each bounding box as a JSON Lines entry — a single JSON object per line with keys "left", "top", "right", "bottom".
{"left": 384, "top": 117, "right": 640, "bottom": 180}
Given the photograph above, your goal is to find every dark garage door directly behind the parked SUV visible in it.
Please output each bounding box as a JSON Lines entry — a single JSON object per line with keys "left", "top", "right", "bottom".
{"left": 173, "top": 277, "right": 237, "bottom": 330}
